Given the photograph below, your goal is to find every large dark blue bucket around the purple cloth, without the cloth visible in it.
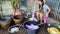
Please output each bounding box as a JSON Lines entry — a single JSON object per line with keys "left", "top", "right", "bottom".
{"left": 23, "top": 21, "right": 40, "bottom": 34}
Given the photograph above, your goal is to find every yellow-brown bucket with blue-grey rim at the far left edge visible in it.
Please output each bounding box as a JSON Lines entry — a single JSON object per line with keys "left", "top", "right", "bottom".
{"left": 0, "top": 17, "right": 11, "bottom": 29}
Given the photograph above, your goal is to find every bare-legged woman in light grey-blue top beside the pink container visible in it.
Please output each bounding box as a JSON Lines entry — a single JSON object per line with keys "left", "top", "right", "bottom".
{"left": 36, "top": 0, "right": 51, "bottom": 22}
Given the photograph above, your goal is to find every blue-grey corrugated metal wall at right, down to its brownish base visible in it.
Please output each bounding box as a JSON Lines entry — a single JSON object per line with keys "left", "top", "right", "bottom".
{"left": 46, "top": 0, "right": 60, "bottom": 20}
